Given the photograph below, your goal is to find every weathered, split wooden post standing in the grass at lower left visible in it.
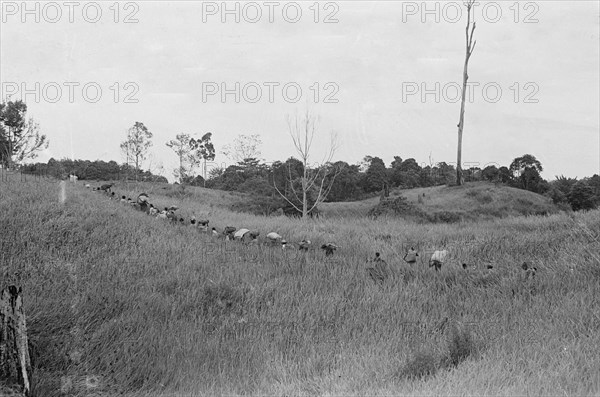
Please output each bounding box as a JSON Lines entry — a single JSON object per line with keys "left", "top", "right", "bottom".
{"left": 0, "top": 285, "right": 31, "bottom": 396}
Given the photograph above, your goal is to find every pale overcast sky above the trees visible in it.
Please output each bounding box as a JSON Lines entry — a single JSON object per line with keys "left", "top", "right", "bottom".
{"left": 0, "top": 1, "right": 600, "bottom": 180}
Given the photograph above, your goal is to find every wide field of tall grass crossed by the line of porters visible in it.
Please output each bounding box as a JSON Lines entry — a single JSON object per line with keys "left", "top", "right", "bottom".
{"left": 0, "top": 174, "right": 600, "bottom": 397}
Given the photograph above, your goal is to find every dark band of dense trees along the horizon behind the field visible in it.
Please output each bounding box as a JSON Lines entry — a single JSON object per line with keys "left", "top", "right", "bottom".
{"left": 20, "top": 150, "right": 600, "bottom": 215}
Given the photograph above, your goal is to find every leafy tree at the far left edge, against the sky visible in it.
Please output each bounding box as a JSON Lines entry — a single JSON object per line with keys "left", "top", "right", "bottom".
{"left": 0, "top": 101, "right": 49, "bottom": 168}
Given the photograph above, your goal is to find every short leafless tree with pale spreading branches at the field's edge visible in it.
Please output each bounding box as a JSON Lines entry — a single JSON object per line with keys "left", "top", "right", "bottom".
{"left": 273, "top": 109, "right": 341, "bottom": 221}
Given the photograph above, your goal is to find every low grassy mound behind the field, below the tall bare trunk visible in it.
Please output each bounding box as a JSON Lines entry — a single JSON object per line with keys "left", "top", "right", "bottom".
{"left": 320, "top": 182, "right": 558, "bottom": 222}
